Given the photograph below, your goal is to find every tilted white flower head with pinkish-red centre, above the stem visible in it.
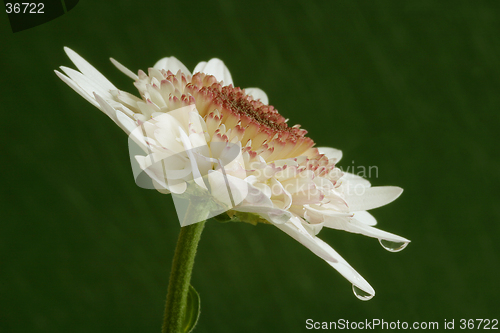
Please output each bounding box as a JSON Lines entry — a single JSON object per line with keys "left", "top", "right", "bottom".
{"left": 55, "top": 48, "right": 409, "bottom": 300}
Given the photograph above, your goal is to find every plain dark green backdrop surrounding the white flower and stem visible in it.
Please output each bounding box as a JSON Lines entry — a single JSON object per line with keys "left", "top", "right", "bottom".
{"left": 0, "top": 0, "right": 500, "bottom": 333}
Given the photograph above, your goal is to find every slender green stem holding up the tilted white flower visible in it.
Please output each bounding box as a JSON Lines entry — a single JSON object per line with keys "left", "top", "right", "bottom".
{"left": 162, "top": 221, "right": 206, "bottom": 333}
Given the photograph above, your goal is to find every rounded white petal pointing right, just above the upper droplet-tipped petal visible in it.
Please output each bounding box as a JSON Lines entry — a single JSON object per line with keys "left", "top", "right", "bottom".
{"left": 345, "top": 186, "right": 403, "bottom": 212}
